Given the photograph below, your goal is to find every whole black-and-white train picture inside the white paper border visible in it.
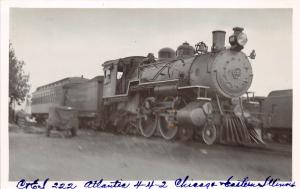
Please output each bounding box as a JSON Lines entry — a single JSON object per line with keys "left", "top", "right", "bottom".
{"left": 1, "top": 3, "right": 295, "bottom": 187}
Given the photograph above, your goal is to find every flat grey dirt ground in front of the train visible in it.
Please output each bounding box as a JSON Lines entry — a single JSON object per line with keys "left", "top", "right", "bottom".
{"left": 9, "top": 126, "right": 292, "bottom": 181}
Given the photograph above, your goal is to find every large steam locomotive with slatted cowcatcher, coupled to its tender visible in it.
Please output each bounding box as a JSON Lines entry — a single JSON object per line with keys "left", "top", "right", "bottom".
{"left": 31, "top": 27, "right": 263, "bottom": 145}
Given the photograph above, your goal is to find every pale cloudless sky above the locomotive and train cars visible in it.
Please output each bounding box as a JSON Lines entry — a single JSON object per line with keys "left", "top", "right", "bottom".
{"left": 9, "top": 8, "right": 293, "bottom": 96}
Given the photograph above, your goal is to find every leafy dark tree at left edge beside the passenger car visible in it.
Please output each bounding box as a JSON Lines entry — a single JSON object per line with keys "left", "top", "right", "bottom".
{"left": 9, "top": 43, "right": 30, "bottom": 122}
